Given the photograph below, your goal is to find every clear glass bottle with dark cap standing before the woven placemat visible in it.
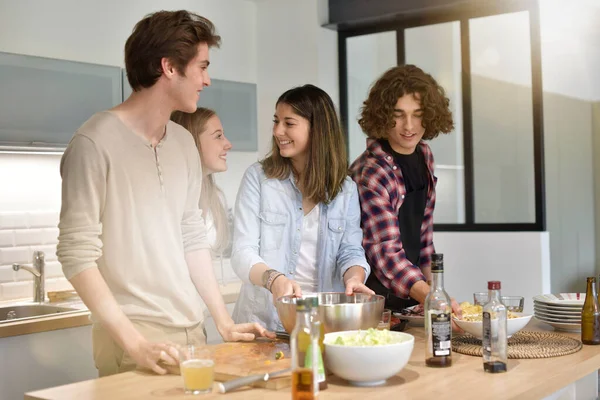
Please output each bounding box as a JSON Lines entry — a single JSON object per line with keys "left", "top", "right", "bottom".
{"left": 482, "top": 281, "right": 508, "bottom": 373}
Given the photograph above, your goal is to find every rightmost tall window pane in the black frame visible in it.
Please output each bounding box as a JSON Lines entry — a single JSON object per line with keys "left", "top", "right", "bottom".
{"left": 469, "top": 11, "right": 535, "bottom": 223}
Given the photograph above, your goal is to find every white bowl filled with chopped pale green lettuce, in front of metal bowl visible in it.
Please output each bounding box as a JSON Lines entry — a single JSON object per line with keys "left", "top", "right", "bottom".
{"left": 323, "top": 329, "right": 415, "bottom": 386}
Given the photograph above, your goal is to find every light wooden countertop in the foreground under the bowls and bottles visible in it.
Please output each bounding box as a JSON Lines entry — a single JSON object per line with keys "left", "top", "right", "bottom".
{"left": 25, "top": 322, "right": 600, "bottom": 400}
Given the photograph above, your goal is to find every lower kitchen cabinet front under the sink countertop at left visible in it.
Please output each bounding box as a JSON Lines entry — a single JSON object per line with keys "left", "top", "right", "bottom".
{"left": 0, "top": 325, "right": 98, "bottom": 400}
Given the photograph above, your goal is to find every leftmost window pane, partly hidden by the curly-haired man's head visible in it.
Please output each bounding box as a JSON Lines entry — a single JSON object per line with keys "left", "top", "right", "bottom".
{"left": 346, "top": 31, "right": 398, "bottom": 163}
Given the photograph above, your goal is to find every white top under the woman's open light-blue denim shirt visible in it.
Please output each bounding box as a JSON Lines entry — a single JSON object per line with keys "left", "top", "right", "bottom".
{"left": 296, "top": 204, "right": 321, "bottom": 292}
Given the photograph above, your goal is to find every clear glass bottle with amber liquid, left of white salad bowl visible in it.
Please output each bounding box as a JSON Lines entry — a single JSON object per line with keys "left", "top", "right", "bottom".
{"left": 290, "top": 299, "right": 319, "bottom": 400}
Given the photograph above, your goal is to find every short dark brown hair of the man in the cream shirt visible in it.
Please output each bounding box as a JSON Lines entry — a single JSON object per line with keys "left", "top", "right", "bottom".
{"left": 125, "top": 10, "right": 221, "bottom": 91}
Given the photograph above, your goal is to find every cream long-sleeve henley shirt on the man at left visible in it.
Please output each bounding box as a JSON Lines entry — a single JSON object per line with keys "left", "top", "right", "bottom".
{"left": 57, "top": 111, "right": 210, "bottom": 327}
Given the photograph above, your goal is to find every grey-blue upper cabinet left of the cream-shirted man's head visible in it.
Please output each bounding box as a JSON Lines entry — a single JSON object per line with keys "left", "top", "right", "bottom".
{"left": 0, "top": 52, "right": 122, "bottom": 147}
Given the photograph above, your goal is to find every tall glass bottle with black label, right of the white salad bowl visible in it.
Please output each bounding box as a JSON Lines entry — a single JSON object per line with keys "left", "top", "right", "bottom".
{"left": 424, "top": 253, "right": 452, "bottom": 367}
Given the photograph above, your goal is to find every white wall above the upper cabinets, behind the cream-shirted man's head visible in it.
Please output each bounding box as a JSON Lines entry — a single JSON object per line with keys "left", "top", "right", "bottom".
{"left": 0, "top": 0, "right": 257, "bottom": 83}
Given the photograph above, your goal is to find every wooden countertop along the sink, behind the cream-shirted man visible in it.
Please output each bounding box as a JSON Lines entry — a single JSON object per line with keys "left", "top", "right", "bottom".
{"left": 0, "top": 282, "right": 241, "bottom": 338}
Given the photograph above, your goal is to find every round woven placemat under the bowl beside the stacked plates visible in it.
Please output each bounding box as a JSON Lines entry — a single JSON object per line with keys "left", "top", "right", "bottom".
{"left": 452, "top": 331, "right": 583, "bottom": 359}
